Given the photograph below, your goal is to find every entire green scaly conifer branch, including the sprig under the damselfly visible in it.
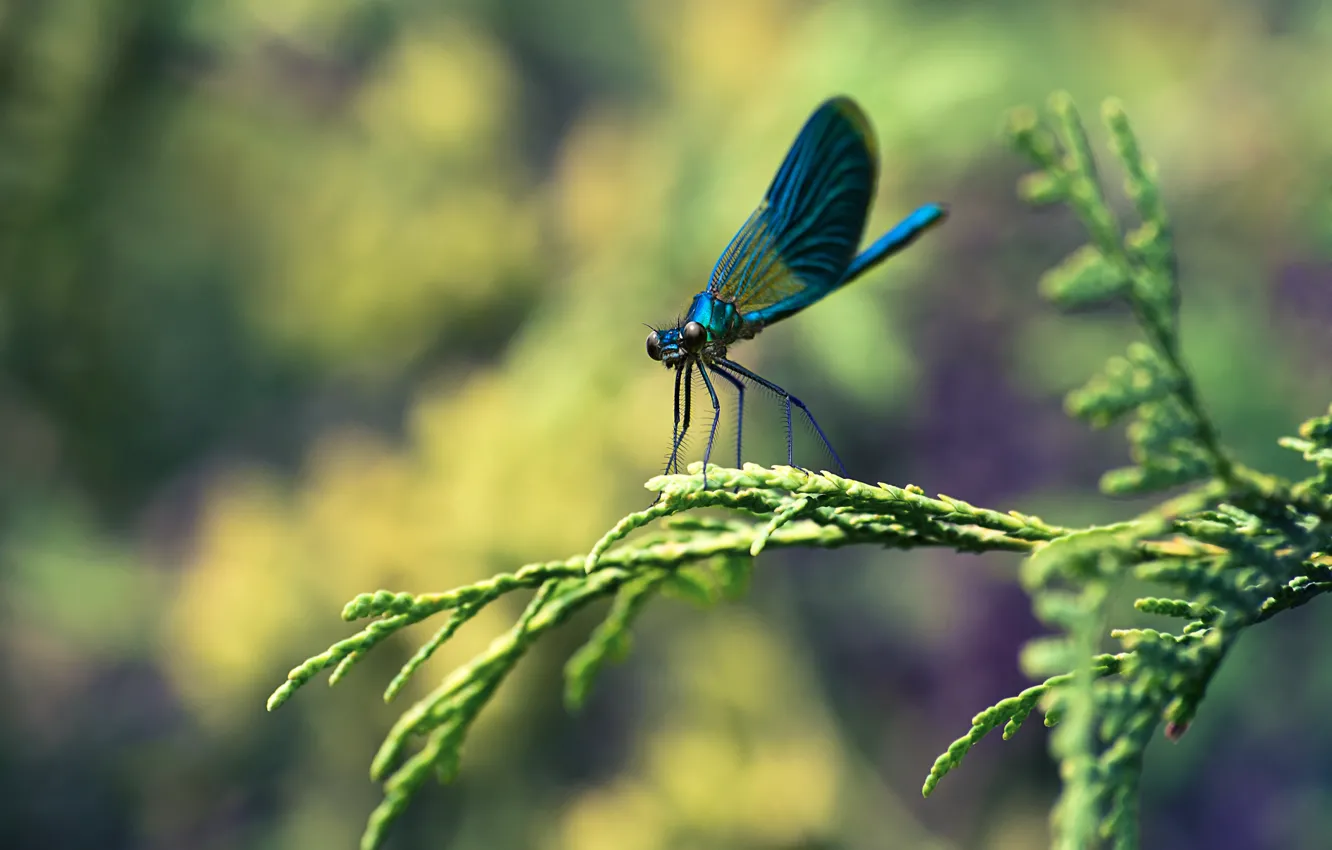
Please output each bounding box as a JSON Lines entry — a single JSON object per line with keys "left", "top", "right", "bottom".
{"left": 268, "top": 95, "right": 1332, "bottom": 849}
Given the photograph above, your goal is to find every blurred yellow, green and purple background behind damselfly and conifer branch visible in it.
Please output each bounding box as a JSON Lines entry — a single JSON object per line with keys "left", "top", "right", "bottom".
{"left": 0, "top": 0, "right": 1332, "bottom": 850}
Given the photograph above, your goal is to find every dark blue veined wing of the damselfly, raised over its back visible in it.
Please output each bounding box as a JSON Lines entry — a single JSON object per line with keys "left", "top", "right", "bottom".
{"left": 707, "top": 97, "right": 879, "bottom": 324}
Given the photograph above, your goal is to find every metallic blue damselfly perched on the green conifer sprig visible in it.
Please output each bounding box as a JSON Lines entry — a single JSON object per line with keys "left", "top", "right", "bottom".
{"left": 647, "top": 96, "right": 947, "bottom": 489}
